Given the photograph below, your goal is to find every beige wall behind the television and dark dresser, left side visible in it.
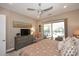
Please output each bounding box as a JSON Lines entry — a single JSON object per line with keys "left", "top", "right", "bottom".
{"left": 0, "top": 8, "right": 35, "bottom": 50}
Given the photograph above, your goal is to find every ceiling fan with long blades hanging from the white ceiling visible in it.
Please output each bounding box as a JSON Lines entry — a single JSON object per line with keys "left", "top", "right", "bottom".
{"left": 27, "top": 3, "right": 53, "bottom": 17}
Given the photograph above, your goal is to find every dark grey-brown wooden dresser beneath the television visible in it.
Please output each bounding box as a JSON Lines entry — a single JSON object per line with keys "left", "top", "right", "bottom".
{"left": 15, "top": 35, "right": 36, "bottom": 50}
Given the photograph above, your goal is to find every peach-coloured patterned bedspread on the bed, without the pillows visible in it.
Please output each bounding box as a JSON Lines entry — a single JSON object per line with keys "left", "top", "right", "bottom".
{"left": 20, "top": 39, "right": 59, "bottom": 56}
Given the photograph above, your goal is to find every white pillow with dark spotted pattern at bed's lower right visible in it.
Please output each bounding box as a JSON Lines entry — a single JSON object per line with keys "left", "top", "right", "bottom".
{"left": 62, "top": 38, "right": 77, "bottom": 56}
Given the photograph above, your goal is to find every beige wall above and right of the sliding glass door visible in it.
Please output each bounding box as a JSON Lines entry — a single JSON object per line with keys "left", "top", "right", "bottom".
{"left": 42, "top": 10, "right": 79, "bottom": 36}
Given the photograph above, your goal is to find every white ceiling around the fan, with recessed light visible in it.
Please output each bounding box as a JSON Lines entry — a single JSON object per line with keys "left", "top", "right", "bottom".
{"left": 0, "top": 3, "right": 79, "bottom": 19}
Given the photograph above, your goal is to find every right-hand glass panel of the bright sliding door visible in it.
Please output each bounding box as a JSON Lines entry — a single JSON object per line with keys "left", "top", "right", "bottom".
{"left": 52, "top": 22, "right": 65, "bottom": 39}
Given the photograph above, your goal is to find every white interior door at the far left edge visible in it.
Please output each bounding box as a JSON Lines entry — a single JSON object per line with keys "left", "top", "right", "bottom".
{"left": 0, "top": 15, "right": 6, "bottom": 56}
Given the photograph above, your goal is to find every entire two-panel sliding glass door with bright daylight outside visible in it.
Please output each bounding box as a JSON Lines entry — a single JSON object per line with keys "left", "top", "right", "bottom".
{"left": 44, "top": 21, "right": 65, "bottom": 39}
